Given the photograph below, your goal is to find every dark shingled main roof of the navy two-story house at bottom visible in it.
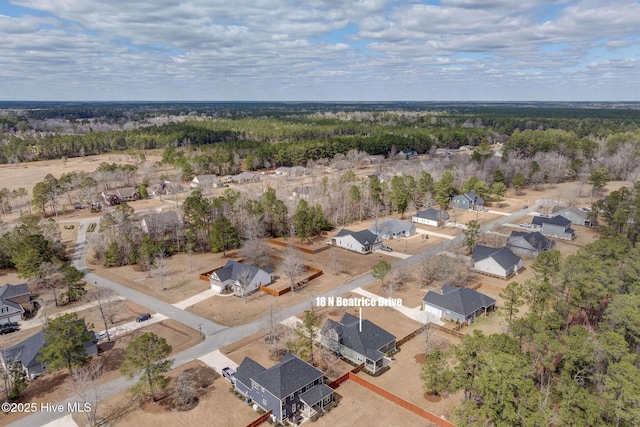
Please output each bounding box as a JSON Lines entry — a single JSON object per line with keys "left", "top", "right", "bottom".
{"left": 249, "top": 353, "right": 323, "bottom": 399}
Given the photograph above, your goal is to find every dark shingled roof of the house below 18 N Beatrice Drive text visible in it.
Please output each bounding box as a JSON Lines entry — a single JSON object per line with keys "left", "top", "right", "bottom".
{"left": 322, "top": 313, "right": 396, "bottom": 361}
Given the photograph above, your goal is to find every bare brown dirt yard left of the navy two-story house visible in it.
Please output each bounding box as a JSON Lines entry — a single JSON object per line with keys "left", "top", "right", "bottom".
{"left": 85, "top": 360, "right": 258, "bottom": 427}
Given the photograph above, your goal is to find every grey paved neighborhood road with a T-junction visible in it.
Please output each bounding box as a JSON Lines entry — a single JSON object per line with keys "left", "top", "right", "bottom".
{"left": 11, "top": 207, "right": 533, "bottom": 427}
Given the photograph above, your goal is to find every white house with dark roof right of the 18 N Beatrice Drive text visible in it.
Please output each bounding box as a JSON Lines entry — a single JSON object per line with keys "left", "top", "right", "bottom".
{"left": 423, "top": 285, "right": 496, "bottom": 325}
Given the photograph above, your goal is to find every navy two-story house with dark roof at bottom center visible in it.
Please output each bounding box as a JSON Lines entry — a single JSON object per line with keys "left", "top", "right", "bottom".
{"left": 235, "top": 353, "right": 333, "bottom": 423}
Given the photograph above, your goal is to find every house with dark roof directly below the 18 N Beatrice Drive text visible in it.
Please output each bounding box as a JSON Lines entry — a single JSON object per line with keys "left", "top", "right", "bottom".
{"left": 320, "top": 313, "right": 396, "bottom": 374}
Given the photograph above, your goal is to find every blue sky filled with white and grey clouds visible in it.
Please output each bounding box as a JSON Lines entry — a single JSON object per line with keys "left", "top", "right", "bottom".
{"left": 0, "top": 0, "right": 640, "bottom": 101}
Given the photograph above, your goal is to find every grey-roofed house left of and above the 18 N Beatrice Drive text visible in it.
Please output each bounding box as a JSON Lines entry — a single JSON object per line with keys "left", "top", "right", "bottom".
{"left": 209, "top": 260, "right": 273, "bottom": 297}
